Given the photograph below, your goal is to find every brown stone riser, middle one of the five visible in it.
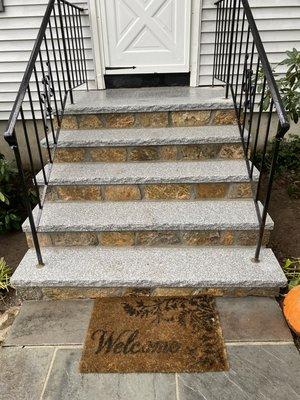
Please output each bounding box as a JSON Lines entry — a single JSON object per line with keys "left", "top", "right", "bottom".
{"left": 42, "top": 182, "right": 252, "bottom": 201}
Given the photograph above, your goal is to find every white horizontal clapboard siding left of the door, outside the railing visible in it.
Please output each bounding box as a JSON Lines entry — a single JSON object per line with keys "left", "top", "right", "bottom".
{"left": 0, "top": 0, "right": 94, "bottom": 120}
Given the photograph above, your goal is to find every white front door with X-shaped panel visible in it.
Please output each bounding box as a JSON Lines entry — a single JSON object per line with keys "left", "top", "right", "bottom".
{"left": 100, "top": 0, "right": 191, "bottom": 74}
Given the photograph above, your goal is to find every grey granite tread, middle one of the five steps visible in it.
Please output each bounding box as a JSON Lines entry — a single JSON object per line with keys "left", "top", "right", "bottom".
{"left": 37, "top": 160, "right": 258, "bottom": 186}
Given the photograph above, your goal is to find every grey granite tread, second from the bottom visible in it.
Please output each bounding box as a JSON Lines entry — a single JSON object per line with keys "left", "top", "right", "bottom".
{"left": 23, "top": 199, "right": 273, "bottom": 232}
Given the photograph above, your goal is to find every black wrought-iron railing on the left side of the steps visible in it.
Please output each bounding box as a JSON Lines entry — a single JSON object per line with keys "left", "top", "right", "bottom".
{"left": 4, "top": 0, "right": 87, "bottom": 266}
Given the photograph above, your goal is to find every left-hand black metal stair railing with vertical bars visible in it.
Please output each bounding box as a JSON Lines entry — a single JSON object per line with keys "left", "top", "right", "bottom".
{"left": 4, "top": 0, "right": 88, "bottom": 265}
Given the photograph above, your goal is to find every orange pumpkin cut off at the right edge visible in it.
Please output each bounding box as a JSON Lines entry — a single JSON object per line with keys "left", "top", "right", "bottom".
{"left": 283, "top": 285, "right": 300, "bottom": 335}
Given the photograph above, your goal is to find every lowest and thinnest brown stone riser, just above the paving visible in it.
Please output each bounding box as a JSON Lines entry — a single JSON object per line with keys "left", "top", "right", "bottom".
{"left": 17, "top": 287, "right": 279, "bottom": 300}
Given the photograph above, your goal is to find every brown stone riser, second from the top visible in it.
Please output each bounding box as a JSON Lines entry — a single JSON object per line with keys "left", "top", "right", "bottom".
{"left": 55, "top": 143, "right": 244, "bottom": 163}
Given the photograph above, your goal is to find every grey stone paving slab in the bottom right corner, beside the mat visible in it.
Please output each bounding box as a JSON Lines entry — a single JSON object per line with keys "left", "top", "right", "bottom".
{"left": 177, "top": 345, "right": 300, "bottom": 400}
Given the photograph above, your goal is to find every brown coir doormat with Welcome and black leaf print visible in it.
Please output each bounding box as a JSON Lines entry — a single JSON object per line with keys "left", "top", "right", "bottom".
{"left": 80, "top": 296, "right": 228, "bottom": 373}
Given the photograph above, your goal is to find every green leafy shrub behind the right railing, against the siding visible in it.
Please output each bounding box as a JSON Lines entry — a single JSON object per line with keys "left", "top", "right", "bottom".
{"left": 257, "top": 48, "right": 300, "bottom": 124}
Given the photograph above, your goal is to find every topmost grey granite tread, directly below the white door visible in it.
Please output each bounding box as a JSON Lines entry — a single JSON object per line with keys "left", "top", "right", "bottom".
{"left": 65, "top": 86, "right": 233, "bottom": 115}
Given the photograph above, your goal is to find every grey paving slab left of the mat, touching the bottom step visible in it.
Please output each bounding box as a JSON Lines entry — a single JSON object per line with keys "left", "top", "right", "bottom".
{"left": 5, "top": 300, "right": 93, "bottom": 346}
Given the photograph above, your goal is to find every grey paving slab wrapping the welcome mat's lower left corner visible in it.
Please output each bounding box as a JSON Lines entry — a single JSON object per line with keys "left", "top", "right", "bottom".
{"left": 42, "top": 349, "right": 176, "bottom": 400}
